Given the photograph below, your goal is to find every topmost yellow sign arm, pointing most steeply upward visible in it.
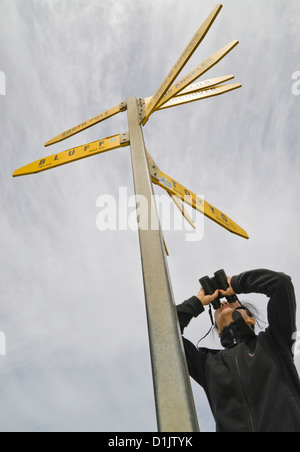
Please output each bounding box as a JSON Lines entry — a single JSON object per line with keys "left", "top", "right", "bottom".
{"left": 143, "top": 5, "right": 222, "bottom": 125}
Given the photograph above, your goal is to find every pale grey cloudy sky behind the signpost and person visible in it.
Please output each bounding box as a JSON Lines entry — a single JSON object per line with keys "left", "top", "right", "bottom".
{"left": 0, "top": 0, "right": 300, "bottom": 432}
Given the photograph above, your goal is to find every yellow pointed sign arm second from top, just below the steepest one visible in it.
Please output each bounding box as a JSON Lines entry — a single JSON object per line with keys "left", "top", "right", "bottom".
{"left": 156, "top": 41, "right": 239, "bottom": 109}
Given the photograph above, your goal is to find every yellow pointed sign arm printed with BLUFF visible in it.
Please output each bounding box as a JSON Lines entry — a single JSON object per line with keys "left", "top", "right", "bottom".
{"left": 13, "top": 132, "right": 130, "bottom": 177}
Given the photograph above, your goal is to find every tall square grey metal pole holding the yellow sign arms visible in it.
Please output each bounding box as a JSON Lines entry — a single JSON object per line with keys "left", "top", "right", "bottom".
{"left": 127, "top": 97, "right": 199, "bottom": 432}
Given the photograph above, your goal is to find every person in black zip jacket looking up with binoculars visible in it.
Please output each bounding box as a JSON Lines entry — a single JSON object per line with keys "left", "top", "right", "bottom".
{"left": 177, "top": 270, "right": 300, "bottom": 432}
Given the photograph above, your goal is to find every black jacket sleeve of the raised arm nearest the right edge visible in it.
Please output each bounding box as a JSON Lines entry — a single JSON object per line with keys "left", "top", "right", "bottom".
{"left": 231, "top": 270, "right": 297, "bottom": 353}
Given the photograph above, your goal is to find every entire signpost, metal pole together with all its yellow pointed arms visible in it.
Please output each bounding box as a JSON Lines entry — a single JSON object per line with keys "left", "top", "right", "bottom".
{"left": 13, "top": 5, "right": 249, "bottom": 432}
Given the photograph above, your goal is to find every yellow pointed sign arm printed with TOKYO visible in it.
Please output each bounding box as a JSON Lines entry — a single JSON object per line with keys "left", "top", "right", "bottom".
{"left": 148, "top": 155, "right": 249, "bottom": 239}
